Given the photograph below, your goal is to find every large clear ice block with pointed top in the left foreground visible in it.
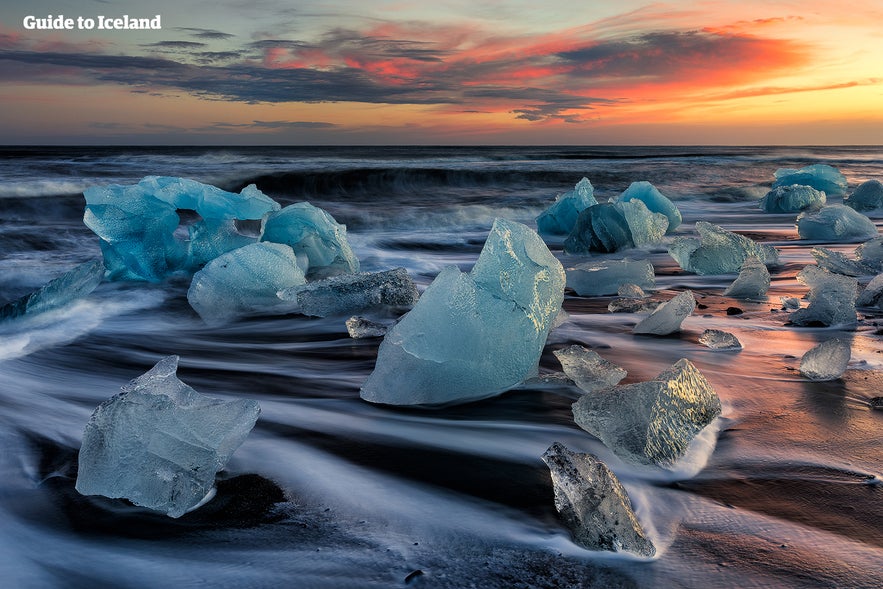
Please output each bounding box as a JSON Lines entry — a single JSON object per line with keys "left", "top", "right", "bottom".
{"left": 76, "top": 356, "right": 260, "bottom": 517}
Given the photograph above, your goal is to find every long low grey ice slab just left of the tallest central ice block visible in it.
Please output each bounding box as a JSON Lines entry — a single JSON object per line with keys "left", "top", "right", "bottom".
{"left": 278, "top": 268, "right": 419, "bottom": 317}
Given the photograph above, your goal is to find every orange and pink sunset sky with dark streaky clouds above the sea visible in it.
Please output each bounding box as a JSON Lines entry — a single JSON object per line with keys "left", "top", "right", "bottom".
{"left": 0, "top": 0, "right": 883, "bottom": 145}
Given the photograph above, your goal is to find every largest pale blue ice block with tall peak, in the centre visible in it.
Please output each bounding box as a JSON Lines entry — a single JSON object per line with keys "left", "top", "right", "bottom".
{"left": 361, "top": 219, "right": 565, "bottom": 405}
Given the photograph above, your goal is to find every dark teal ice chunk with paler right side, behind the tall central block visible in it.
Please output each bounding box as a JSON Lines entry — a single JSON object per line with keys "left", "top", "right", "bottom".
{"left": 564, "top": 200, "right": 668, "bottom": 254}
